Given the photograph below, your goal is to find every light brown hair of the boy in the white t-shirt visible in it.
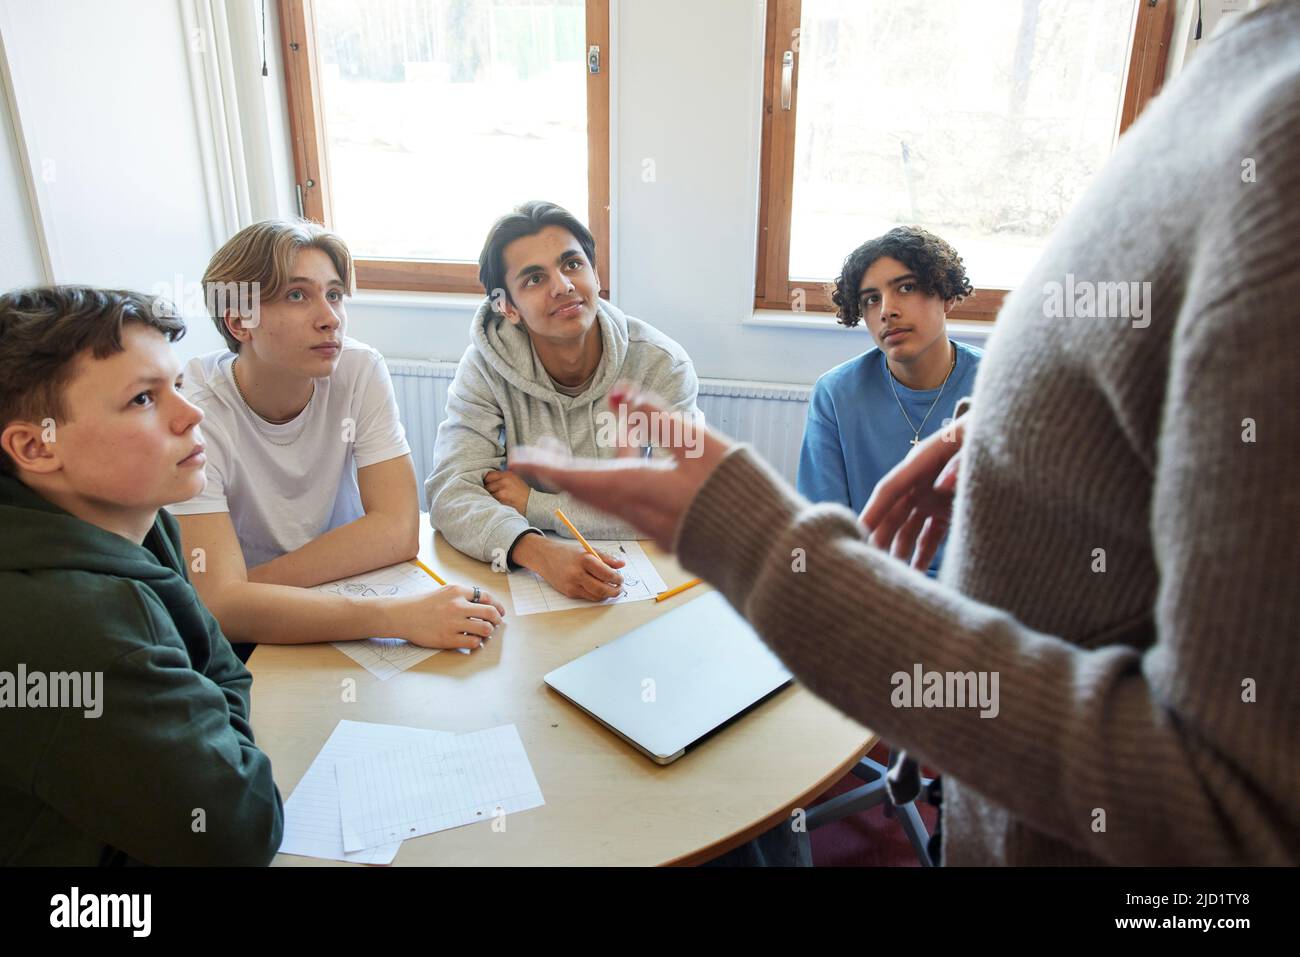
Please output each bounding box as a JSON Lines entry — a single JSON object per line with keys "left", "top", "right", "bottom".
{"left": 203, "top": 220, "right": 356, "bottom": 352}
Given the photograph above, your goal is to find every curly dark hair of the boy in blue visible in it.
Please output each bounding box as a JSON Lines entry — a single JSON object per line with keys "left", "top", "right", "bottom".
{"left": 828, "top": 226, "right": 975, "bottom": 328}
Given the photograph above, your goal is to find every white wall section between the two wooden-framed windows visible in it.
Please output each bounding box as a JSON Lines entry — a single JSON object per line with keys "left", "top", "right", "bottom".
{"left": 615, "top": 0, "right": 889, "bottom": 382}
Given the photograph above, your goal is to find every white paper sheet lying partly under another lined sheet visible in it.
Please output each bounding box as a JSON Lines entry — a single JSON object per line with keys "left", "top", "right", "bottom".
{"left": 280, "top": 720, "right": 455, "bottom": 863}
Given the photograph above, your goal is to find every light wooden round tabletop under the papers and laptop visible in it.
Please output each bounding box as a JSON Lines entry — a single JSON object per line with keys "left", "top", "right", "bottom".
{"left": 248, "top": 516, "right": 876, "bottom": 866}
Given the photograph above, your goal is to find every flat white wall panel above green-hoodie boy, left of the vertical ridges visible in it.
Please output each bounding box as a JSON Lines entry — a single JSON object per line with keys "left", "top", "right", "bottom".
{"left": 0, "top": 0, "right": 227, "bottom": 355}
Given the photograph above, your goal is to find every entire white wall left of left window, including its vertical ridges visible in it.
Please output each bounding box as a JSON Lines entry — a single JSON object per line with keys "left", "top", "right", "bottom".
{"left": 0, "top": 0, "right": 295, "bottom": 358}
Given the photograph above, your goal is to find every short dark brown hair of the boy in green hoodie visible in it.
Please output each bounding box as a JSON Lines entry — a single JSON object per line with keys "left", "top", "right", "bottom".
{"left": 0, "top": 286, "right": 185, "bottom": 475}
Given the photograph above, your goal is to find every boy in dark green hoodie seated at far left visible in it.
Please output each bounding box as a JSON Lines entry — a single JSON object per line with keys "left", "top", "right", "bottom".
{"left": 0, "top": 286, "right": 283, "bottom": 865}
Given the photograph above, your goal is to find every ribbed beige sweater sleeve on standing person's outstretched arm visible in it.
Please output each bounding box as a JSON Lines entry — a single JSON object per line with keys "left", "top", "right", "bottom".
{"left": 677, "top": 418, "right": 1300, "bottom": 863}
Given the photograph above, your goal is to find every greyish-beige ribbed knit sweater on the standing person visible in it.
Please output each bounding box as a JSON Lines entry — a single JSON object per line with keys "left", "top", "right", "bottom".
{"left": 676, "top": 0, "right": 1300, "bottom": 865}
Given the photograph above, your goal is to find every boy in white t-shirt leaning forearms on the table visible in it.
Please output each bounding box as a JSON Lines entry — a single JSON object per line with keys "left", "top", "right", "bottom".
{"left": 170, "top": 220, "right": 504, "bottom": 653}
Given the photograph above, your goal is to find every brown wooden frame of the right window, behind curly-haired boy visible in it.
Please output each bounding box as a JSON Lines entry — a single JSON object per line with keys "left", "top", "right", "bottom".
{"left": 754, "top": 0, "right": 1174, "bottom": 322}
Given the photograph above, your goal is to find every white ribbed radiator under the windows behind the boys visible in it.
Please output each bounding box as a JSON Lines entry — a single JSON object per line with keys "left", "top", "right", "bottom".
{"left": 387, "top": 359, "right": 811, "bottom": 508}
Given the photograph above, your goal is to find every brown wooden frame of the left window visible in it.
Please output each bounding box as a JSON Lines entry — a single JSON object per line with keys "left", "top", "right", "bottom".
{"left": 278, "top": 0, "right": 610, "bottom": 298}
